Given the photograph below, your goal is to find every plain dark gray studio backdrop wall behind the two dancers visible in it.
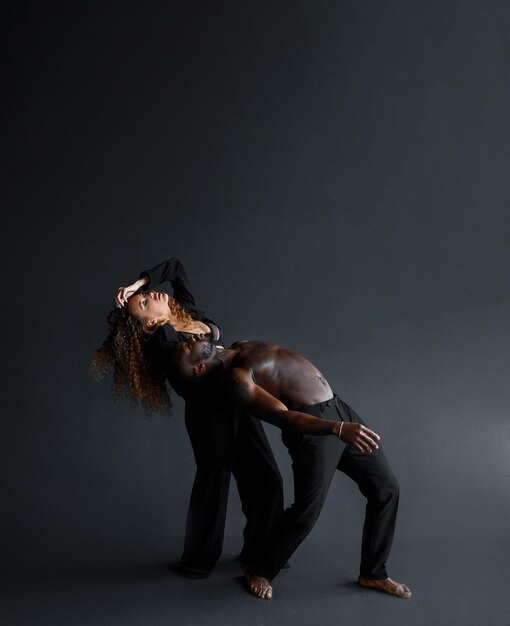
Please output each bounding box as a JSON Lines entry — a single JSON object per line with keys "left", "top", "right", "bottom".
{"left": 1, "top": 0, "right": 510, "bottom": 620}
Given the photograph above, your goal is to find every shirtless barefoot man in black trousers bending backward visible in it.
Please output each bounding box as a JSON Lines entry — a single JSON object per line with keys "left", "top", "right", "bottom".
{"left": 170, "top": 338, "right": 411, "bottom": 599}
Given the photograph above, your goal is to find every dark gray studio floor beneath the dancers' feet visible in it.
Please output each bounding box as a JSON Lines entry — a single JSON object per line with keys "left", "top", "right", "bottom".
{"left": 0, "top": 537, "right": 504, "bottom": 626}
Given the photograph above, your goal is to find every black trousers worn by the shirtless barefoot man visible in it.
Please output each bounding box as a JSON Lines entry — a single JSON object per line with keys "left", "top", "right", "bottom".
{"left": 250, "top": 395, "right": 399, "bottom": 580}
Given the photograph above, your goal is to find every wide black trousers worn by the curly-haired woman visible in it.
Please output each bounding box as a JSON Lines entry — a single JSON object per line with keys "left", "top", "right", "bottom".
{"left": 181, "top": 396, "right": 283, "bottom": 577}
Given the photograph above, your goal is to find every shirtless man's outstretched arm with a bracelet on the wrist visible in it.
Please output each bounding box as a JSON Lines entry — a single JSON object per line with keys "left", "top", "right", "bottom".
{"left": 229, "top": 367, "right": 379, "bottom": 452}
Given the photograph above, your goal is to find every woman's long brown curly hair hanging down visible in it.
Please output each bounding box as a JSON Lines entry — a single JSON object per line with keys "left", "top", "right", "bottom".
{"left": 91, "top": 303, "right": 175, "bottom": 414}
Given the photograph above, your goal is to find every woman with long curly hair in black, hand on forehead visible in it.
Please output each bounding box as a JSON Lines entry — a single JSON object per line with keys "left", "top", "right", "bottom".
{"left": 92, "top": 257, "right": 283, "bottom": 578}
